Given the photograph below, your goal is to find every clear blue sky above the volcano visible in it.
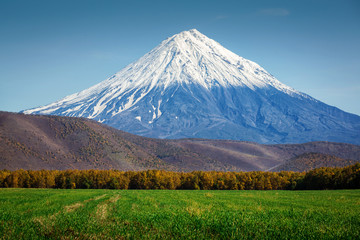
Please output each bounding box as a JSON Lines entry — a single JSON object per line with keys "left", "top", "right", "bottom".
{"left": 0, "top": 0, "right": 360, "bottom": 115}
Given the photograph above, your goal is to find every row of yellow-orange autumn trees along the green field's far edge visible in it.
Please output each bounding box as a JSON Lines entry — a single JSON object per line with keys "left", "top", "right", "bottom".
{"left": 0, "top": 163, "right": 360, "bottom": 190}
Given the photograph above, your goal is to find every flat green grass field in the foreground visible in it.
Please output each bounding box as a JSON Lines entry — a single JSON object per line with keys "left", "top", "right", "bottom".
{"left": 0, "top": 189, "right": 360, "bottom": 239}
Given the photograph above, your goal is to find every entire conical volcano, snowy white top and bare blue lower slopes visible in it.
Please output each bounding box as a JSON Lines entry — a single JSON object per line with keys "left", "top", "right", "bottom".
{"left": 24, "top": 29, "right": 360, "bottom": 144}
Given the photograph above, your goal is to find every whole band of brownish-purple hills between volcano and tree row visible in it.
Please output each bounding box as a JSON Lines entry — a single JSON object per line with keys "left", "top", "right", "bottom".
{"left": 0, "top": 112, "right": 360, "bottom": 171}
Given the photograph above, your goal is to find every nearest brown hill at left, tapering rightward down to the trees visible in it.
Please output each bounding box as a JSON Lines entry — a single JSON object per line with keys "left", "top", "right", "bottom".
{"left": 0, "top": 112, "right": 255, "bottom": 171}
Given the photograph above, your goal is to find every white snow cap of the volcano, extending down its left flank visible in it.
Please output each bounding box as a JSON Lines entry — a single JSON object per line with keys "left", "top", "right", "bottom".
{"left": 25, "top": 29, "right": 300, "bottom": 118}
